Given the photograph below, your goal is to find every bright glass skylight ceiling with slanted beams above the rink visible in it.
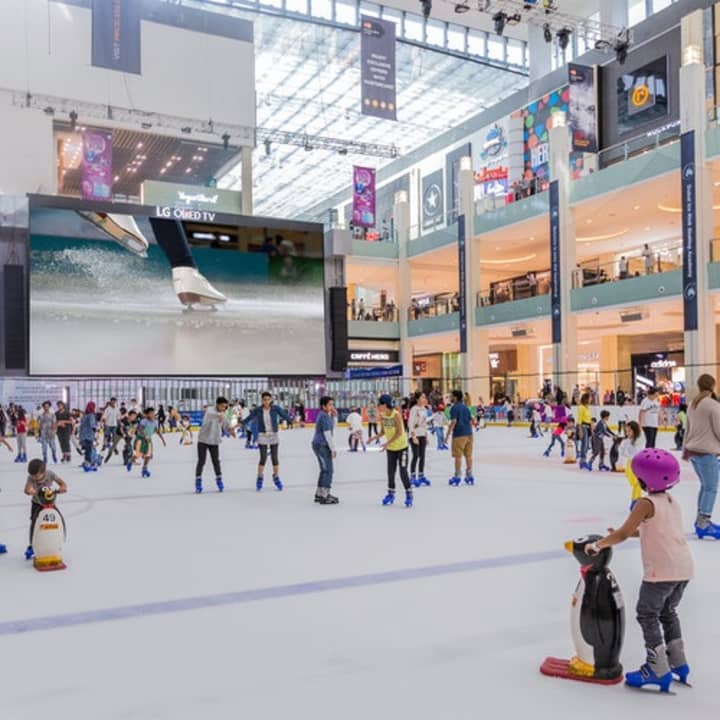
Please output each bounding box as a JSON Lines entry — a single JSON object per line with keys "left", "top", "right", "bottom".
{"left": 179, "top": 0, "right": 527, "bottom": 218}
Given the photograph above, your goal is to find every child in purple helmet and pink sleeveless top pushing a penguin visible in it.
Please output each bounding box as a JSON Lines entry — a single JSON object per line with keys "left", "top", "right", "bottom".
{"left": 585, "top": 448, "right": 693, "bottom": 692}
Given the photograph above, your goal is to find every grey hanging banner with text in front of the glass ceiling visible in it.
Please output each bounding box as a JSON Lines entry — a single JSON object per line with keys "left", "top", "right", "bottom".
{"left": 360, "top": 15, "right": 397, "bottom": 120}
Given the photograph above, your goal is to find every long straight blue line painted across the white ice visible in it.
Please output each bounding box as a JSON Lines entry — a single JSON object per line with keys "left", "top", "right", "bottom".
{"left": 0, "top": 550, "right": 567, "bottom": 636}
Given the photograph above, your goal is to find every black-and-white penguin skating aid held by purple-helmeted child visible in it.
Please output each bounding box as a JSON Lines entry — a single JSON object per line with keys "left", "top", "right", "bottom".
{"left": 540, "top": 535, "right": 625, "bottom": 685}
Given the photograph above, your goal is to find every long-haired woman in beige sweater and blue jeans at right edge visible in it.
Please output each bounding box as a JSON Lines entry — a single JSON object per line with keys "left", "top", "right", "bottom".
{"left": 683, "top": 375, "right": 720, "bottom": 540}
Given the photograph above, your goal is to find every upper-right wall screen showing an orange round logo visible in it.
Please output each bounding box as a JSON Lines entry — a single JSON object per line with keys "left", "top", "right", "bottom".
{"left": 617, "top": 57, "right": 668, "bottom": 135}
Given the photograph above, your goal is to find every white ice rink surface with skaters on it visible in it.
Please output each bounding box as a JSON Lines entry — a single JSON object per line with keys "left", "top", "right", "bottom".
{"left": 0, "top": 428, "right": 720, "bottom": 720}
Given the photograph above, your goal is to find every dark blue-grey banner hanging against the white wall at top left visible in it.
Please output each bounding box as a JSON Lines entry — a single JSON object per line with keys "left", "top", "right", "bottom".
{"left": 91, "top": 0, "right": 142, "bottom": 75}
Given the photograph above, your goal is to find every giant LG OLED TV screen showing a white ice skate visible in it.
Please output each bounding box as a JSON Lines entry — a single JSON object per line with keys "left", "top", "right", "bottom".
{"left": 29, "top": 197, "right": 326, "bottom": 376}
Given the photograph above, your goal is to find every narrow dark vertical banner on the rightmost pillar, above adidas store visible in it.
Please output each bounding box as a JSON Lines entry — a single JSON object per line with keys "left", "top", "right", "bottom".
{"left": 680, "top": 130, "right": 698, "bottom": 330}
